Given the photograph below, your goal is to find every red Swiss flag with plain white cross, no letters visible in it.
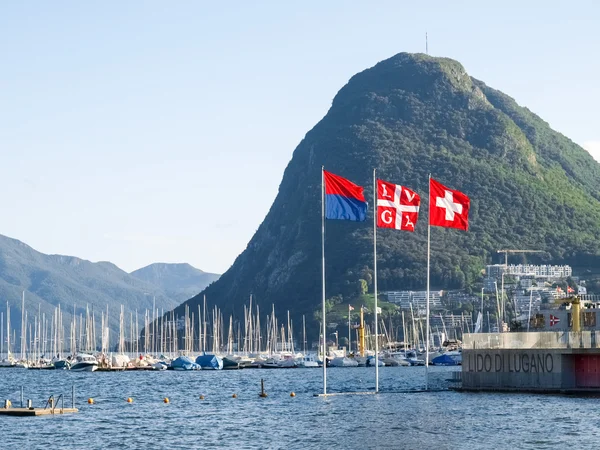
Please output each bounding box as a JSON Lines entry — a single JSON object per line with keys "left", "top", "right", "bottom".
{"left": 429, "top": 178, "right": 471, "bottom": 231}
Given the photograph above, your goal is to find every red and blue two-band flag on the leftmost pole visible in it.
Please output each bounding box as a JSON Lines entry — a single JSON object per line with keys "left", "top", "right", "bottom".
{"left": 323, "top": 170, "right": 367, "bottom": 222}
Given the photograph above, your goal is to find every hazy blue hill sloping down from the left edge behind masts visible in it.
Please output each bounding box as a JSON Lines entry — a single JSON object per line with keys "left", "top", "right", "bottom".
{"left": 0, "top": 235, "right": 179, "bottom": 350}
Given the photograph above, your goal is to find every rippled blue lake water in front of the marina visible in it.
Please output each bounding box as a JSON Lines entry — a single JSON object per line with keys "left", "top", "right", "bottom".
{"left": 0, "top": 367, "right": 600, "bottom": 449}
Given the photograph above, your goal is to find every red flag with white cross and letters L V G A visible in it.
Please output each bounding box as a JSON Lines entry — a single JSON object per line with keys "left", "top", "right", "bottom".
{"left": 377, "top": 180, "right": 421, "bottom": 231}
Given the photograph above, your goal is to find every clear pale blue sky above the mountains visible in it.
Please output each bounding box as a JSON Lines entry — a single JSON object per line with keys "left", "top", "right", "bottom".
{"left": 0, "top": 1, "right": 600, "bottom": 272}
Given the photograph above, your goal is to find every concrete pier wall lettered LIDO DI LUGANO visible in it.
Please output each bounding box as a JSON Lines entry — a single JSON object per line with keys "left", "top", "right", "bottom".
{"left": 461, "top": 331, "right": 600, "bottom": 395}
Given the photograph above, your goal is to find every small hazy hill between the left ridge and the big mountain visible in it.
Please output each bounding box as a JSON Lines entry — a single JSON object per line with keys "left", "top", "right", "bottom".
{"left": 130, "top": 263, "right": 220, "bottom": 302}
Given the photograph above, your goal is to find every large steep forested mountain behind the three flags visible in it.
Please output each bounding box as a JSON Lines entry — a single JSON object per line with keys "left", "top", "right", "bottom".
{"left": 171, "top": 53, "right": 600, "bottom": 328}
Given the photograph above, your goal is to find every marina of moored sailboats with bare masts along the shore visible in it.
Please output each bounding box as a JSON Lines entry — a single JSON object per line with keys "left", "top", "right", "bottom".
{"left": 0, "top": 295, "right": 462, "bottom": 372}
